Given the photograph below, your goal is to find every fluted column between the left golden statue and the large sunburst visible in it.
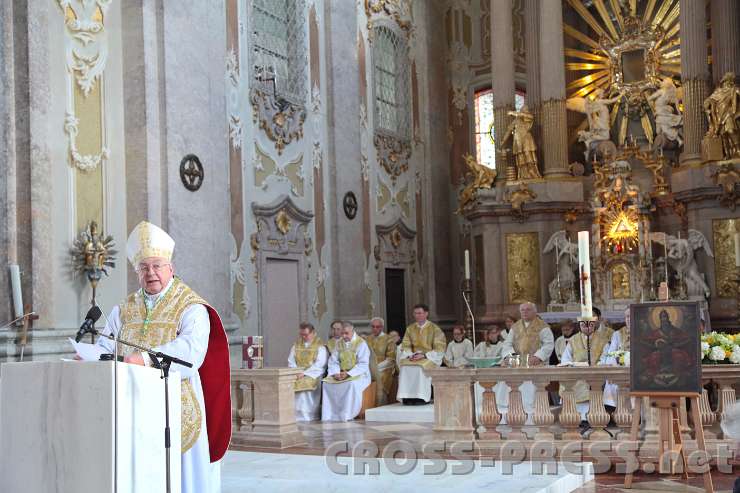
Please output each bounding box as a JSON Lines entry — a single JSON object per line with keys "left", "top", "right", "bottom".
{"left": 539, "top": 0, "right": 568, "bottom": 178}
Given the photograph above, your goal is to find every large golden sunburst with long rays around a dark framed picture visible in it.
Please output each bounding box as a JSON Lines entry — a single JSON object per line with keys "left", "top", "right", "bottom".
{"left": 564, "top": 0, "right": 681, "bottom": 145}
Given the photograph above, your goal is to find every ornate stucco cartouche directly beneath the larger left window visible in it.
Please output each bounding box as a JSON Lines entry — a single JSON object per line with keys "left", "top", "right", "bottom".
{"left": 249, "top": 88, "right": 306, "bottom": 154}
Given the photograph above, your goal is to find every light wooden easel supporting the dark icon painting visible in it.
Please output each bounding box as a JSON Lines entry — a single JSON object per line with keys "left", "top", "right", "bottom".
{"left": 624, "top": 392, "right": 714, "bottom": 493}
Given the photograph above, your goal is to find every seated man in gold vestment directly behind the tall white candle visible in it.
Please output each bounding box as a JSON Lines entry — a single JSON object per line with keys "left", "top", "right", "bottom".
{"left": 560, "top": 307, "right": 613, "bottom": 422}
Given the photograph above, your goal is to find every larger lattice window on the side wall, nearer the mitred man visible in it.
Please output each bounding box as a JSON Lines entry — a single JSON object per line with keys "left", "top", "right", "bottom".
{"left": 249, "top": 0, "right": 308, "bottom": 106}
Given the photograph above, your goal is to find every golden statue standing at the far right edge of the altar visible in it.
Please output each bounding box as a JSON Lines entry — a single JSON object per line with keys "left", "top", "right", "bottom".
{"left": 704, "top": 72, "right": 740, "bottom": 159}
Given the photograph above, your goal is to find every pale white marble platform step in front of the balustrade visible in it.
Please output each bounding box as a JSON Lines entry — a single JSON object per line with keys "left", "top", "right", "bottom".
{"left": 221, "top": 451, "right": 593, "bottom": 493}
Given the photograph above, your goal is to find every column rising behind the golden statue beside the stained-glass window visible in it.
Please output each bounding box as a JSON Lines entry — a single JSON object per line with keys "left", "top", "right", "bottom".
{"left": 491, "top": 0, "right": 516, "bottom": 181}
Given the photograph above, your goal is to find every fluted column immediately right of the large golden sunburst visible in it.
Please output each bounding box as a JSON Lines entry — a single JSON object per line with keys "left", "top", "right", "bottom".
{"left": 680, "top": 0, "right": 709, "bottom": 163}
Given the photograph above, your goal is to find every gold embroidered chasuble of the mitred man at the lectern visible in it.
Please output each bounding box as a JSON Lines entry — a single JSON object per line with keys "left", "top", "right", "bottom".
{"left": 118, "top": 278, "right": 208, "bottom": 453}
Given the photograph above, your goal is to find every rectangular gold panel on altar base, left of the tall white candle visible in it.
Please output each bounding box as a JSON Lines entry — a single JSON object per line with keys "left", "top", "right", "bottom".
{"left": 506, "top": 232, "right": 540, "bottom": 304}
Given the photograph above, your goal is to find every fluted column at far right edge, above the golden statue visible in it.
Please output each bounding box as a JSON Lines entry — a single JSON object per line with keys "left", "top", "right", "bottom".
{"left": 709, "top": 0, "right": 740, "bottom": 86}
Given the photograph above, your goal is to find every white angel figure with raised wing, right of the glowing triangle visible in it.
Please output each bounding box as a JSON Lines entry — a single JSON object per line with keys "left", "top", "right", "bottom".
{"left": 650, "top": 229, "right": 714, "bottom": 298}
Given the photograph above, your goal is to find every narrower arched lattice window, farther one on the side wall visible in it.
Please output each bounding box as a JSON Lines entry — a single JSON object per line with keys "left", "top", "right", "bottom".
{"left": 373, "top": 25, "right": 411, "bottom": 140}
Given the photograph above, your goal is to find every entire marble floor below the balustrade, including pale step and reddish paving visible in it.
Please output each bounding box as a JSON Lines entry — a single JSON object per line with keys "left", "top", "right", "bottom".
{"left": 228, "top": 420, "right": 740, "bottom": 493}
